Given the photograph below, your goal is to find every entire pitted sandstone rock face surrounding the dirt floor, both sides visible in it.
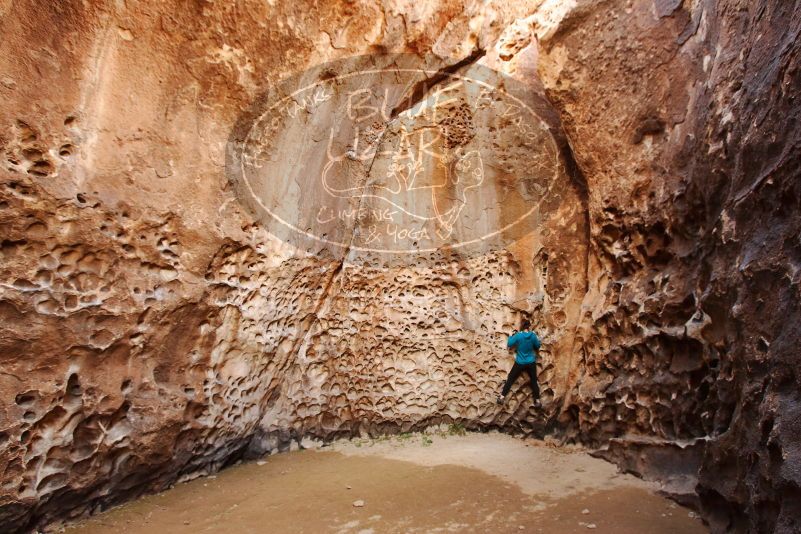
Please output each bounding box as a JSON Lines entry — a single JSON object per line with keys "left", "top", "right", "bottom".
{"left": 0, "top": 0, "right": 801, "bottom": 532}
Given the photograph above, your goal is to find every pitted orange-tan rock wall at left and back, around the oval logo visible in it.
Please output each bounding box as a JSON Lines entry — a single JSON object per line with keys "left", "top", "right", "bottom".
{"left": 0, "top": 2, "right": 587, "bottom": 530}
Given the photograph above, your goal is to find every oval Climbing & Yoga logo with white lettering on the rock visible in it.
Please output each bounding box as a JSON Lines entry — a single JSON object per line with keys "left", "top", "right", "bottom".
{"left": 226, "top": 56, "right": 560, "bottom": 255}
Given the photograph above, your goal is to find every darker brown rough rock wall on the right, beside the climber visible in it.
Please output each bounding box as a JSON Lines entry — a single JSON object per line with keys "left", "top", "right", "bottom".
{"left": 540, "top": 1, "right": 801, "bottom": 532}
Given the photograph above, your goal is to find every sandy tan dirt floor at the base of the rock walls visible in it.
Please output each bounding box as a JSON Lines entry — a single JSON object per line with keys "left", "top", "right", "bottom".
{"left": 67, "top": 431, "right": 707, "bottom": 534}
